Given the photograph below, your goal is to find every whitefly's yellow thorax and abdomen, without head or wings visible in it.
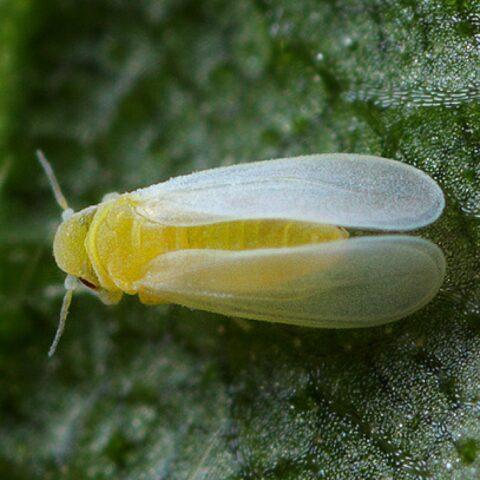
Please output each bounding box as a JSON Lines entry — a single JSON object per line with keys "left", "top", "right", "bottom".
{"left": 86, "top": 196, "right": 348, "bottom": 294}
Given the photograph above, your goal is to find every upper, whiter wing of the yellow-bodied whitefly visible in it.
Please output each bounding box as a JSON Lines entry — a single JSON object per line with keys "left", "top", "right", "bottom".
{"left": 131, "top": 154, "right": 444, "bottom": 230}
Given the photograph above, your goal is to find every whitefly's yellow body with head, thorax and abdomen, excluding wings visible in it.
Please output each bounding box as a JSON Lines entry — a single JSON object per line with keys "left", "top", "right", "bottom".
{"left": 54, "top": 194, "right": 348, "bottom": 303}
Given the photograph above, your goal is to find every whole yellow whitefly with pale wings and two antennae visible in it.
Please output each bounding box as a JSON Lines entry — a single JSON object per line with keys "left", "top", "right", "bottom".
{"left": 38, "top": 152, "right": 445, "bottom": 355}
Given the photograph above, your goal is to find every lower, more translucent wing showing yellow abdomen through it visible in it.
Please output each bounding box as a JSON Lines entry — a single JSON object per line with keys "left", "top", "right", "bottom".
{"left": 136, "top": 236, "right": 445, "bottom": 328}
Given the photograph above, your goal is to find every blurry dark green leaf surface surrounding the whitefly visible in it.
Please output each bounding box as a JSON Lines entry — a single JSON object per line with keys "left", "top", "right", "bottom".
{"left": 0, "top": 0, "right": 480, "bottom": 480}
